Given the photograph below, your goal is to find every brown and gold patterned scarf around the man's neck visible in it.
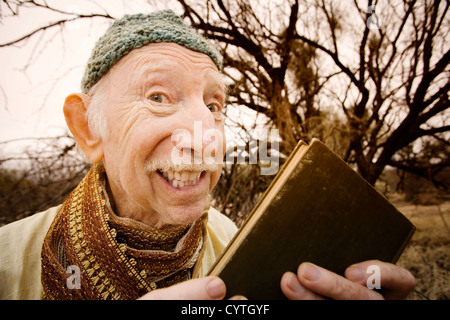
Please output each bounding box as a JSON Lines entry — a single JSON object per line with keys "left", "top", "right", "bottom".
{"left": 41, "top": 165, "right": 209, "bottom": 300}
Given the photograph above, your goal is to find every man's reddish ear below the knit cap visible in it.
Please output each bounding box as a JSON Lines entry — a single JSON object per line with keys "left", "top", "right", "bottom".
{"left": 63, "top": 93, "right": 103, "bottom": 163}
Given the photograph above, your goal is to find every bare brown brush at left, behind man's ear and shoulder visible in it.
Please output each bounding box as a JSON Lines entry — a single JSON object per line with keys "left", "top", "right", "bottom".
{"left": 0, "top": 135, "right": 90, "bottom": 226}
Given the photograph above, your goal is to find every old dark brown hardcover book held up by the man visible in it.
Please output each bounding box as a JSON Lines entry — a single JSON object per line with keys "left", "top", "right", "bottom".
{"left": 209, "top": 139, "right": 415, "bottom": 299}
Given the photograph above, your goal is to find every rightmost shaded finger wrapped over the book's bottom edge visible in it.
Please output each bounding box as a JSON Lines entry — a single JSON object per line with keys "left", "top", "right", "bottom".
{"left": 345, "top": 260, "right": 416, "bottom": 299}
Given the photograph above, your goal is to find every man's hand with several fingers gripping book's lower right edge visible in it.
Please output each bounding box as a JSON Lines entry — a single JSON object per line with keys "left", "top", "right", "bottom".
{"left": 281, "top": 260, "right": 415, "bottom": 300}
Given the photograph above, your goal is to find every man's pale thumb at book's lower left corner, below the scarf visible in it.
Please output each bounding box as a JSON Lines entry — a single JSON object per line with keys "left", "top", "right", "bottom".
{"left": 140, "top": 276, "right": 226, "bottom": 300}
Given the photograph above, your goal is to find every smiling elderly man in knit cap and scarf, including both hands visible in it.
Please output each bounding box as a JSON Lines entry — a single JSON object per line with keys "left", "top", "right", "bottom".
{"left": 0, "top": 11, "right": 414, "bottom": 299}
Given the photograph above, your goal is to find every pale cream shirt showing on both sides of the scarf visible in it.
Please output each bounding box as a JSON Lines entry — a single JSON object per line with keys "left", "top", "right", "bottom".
{"left": 0, "top": 206, "right": 237, "bottom": 300}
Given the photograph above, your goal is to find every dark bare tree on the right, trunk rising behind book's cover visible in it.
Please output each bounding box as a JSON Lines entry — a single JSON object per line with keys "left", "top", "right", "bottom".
{"left": 306, "top": 0, "right": 450, "bottom": 183}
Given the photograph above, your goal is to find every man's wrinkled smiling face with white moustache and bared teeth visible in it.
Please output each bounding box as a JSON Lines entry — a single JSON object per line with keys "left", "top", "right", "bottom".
{"left": 83, "top": 43, "right": 225, "bottom": 228}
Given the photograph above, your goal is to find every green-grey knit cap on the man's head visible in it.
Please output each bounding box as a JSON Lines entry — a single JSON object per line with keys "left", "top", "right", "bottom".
{"left": 81, "top": 10, "right": 222, "bottom": 93}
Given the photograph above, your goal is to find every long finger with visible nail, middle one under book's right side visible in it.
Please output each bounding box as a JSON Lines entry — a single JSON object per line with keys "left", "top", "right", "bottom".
{"left": 297, "top": 263, "right": 383, "bottom": 300}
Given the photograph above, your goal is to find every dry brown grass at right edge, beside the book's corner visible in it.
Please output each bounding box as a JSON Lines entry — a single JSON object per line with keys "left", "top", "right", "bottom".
{"left": 391, "top": 198, "right": 450, "bottom": 300}
